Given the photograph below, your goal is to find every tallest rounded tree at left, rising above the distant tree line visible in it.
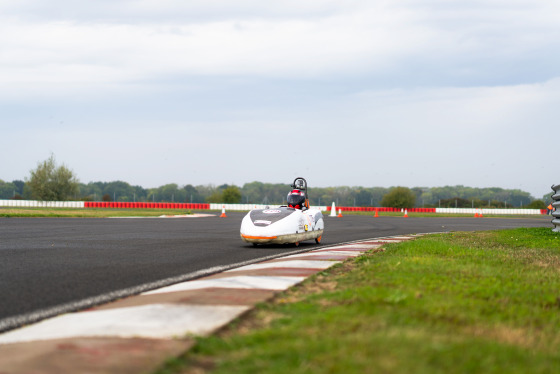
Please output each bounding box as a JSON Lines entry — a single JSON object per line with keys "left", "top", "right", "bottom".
{"left": 25, "top": 154, "right": 79, "bottom": 201}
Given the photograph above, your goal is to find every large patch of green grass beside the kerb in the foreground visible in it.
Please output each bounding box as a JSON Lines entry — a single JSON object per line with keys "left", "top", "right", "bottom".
{"left": 158, "top": 228, "right": 560, "bottom": 374}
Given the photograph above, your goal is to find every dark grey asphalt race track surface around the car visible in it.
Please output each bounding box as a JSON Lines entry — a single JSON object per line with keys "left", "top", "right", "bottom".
{"left": 0, "top": 212, "right": 552, "bottom": 331}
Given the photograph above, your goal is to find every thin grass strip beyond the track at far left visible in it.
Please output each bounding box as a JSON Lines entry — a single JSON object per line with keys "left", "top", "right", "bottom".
{"left": 0, "top": 207, "right": 192, "bottom": 218}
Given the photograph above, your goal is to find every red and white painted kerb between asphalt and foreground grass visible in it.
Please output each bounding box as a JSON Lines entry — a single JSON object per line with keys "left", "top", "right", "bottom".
{"left": 0, "top": 235, "right": 418, "bottom": 374}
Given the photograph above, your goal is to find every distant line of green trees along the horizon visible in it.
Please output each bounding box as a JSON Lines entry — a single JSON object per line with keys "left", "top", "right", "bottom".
{"left": 0, "top": 155, "right": 550, "bottom": 209}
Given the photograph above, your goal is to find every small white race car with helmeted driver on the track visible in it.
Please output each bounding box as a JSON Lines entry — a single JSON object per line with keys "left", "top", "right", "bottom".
{"left": 240, "top": 178, "right": 325, "bottom": 246}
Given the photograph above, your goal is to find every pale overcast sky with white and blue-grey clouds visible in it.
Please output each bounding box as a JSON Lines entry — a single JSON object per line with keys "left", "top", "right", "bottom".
{"left": 0, "top": 0, "right": 560, "bottom": 197}
